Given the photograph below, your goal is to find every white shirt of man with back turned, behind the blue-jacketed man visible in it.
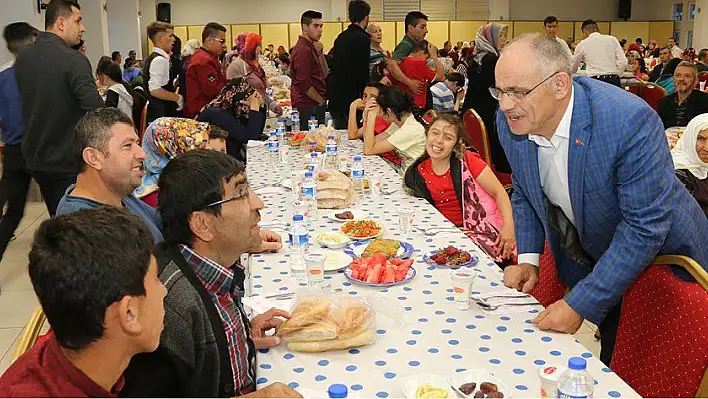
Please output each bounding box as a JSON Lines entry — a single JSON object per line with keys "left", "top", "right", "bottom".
{"left": 572, "top": 32, "right": 627, "bottom": 76}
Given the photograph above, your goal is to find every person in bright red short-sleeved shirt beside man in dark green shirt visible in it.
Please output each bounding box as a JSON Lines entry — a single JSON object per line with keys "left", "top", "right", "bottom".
{"left": 388, "top": 39, "right": 445, "bottom": 109}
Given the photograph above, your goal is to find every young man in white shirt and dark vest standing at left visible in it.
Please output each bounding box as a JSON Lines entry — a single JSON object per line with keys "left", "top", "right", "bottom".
{"left": 143, "top": 21, "right": 184, "bottom": 124}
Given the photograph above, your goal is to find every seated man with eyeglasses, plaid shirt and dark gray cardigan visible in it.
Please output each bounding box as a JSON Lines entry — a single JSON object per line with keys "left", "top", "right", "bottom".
{"left": 123, "top": 150, "right": 299, "bottom": 397}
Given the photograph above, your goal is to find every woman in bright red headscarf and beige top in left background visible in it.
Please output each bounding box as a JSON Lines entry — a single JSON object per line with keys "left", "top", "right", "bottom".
{"left": 226, "top": 32, "right": 283, "bottom": 115}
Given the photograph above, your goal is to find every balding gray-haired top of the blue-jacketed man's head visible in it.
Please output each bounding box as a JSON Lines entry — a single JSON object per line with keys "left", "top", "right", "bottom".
{"left": 502, "top": 33, "right": 573, "bottom": 77}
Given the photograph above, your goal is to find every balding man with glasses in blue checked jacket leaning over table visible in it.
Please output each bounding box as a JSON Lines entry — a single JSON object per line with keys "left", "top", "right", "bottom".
{"left": 492, "top": 35, "right": 708, "bottom": 364}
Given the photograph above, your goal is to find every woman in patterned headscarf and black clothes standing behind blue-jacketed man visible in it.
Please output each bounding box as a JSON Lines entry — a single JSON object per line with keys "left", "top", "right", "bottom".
{"left": 462, "top": 23, "right": 511, "bottom": 173}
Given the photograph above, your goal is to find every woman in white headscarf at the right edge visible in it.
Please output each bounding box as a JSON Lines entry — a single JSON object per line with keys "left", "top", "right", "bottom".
{"left": 671, "top": 114, "right": 708, "bottom": 216}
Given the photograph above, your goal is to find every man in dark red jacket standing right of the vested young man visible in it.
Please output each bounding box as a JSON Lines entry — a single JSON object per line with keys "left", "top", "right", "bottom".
{"left": 185, "top": 22, "right": 226, "bottom": 118}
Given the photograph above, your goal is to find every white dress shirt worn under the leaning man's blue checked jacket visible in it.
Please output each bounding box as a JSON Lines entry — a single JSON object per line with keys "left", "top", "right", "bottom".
{"left": 519, "top": 88, "right": 575, "bottom": 266}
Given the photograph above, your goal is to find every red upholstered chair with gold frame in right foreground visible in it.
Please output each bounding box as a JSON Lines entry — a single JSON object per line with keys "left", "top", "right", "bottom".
{"left": 611, "top": 256, "right": 708, "bottom": 398}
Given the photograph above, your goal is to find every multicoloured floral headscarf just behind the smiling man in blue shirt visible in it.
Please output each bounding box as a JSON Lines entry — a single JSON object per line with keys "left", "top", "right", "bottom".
{"left": 134, "top": 118, "right": 210, "bottom": 198}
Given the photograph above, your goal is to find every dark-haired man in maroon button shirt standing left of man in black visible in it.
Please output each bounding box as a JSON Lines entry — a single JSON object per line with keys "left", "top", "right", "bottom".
{"left": 290, "top": 10, "right": 327, "bottom": 130}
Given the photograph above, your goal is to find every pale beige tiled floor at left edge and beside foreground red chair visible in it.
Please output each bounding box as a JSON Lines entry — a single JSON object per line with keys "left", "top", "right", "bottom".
{"left": 0, "top": 202, "right": 600, "bottom": 373}
